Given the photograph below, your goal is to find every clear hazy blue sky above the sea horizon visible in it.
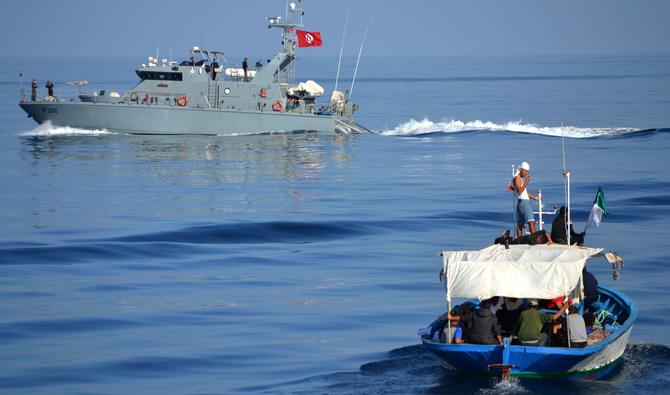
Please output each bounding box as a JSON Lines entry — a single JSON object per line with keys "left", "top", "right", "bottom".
{"left": 0, "top": 0, "right": 670, "bottom": 57}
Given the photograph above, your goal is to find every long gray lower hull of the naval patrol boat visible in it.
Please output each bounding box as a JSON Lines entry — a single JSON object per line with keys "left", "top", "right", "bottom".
{"left": 19, "top": 102, "right": 362, "bottom": 136}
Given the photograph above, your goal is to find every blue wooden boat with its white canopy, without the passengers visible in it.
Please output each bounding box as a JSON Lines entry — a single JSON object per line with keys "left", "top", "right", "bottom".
{"left": 422, "top": 245, "right": 638, "bottom": 380}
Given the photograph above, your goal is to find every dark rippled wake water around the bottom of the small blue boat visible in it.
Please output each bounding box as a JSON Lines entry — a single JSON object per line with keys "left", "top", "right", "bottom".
{"left": 258, "top": 343, "right": 670, "bottom": 395}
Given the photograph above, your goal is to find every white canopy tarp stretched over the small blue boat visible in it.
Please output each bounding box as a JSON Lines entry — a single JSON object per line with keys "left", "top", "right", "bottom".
{"left": 442, "top": 244, "right": 602, "bottom": 300}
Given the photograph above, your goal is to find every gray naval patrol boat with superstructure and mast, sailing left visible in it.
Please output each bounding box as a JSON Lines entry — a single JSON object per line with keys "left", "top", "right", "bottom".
{"left": 19, "top": 1, "right": 369, "bottom": 135}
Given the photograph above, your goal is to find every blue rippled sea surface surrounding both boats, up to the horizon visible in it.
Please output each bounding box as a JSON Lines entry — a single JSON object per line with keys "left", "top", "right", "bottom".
{"left": 0, "top": 55, "right": 670, "bottom": 394}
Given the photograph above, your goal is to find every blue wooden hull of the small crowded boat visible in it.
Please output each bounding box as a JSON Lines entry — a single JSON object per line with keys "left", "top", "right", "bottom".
{"left": 422, "top": 287, "right": 637, "bottom": 380}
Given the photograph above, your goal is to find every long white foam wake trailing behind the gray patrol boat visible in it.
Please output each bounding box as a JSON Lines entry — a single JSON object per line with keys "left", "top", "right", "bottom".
{"left": 381, "top": 118, "right": 638, "bottom": 138}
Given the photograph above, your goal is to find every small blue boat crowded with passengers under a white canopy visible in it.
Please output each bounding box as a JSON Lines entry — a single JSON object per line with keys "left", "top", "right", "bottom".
{"left": 418, "top": 162, "right": 638, "bottom": 379}
